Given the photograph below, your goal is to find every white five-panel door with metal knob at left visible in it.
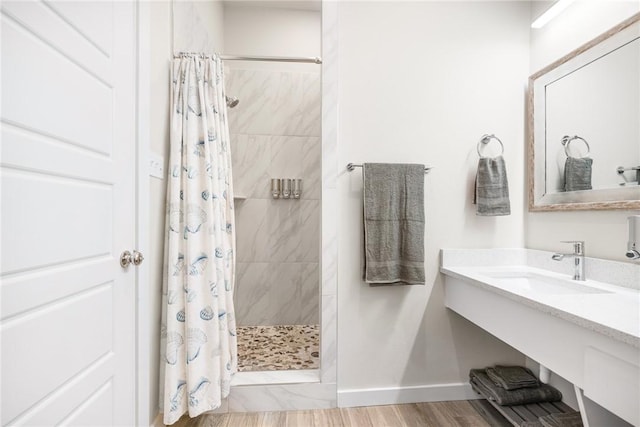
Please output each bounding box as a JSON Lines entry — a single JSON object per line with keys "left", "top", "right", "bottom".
{"left": 0, "top": 0, "right": 136, "bottom": 426}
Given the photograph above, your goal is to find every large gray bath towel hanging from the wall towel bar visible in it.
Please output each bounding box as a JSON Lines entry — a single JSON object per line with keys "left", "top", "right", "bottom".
{"left": 362, "top": 163, "right": 425, "bottom": 285}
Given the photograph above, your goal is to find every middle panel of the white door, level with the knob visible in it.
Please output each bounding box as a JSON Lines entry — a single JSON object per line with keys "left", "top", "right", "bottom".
{"left": 1, "top": 171, "right": 113, "bottom": 274}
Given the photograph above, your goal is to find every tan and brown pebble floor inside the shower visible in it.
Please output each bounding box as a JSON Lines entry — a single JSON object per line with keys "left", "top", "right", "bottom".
{"left": 236, "top": 325, "right": 320, "bottom": 372}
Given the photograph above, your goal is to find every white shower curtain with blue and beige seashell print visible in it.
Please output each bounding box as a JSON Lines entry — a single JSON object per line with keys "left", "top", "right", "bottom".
{"left": 160, "top": 54, "right": 237, "bottom": 424}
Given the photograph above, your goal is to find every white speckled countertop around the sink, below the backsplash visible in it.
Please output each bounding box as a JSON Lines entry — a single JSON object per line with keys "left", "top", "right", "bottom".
{"left": 440, "top": 249, "right": 640, "bottom": 348}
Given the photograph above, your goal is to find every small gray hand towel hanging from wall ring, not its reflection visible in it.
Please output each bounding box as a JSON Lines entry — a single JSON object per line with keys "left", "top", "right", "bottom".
{"left": 473, "top": 156, "right": 511, "bottom": 216}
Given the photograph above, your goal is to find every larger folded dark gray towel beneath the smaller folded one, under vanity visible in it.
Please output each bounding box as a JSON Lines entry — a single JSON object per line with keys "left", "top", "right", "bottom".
{"left": 469, "top": 369, "right": 562, "bottom": 406}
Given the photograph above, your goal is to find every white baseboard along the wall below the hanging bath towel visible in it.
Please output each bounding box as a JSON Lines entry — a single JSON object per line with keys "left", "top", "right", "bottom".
{"left": 338, "top": 383, "right": 478, "bottom": 408}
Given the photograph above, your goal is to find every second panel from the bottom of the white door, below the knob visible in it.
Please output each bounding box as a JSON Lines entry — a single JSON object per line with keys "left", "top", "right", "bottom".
{"left": 2, "top": 283, "right": 113, "bottom": 424}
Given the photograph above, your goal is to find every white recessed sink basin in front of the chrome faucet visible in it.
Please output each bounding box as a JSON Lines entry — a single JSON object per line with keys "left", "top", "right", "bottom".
{"left": 483, "top": 271, "right": 612, "bottom": 295}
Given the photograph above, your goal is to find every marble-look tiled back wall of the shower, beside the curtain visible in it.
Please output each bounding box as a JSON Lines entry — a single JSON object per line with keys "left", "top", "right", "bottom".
{"left": 226, "top": 68, "right": 322, "bottom": 326}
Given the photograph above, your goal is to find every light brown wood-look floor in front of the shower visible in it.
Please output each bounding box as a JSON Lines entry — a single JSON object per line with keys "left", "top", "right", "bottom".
{"left": 174, "top": 400, "right": 489, "bottom": 427}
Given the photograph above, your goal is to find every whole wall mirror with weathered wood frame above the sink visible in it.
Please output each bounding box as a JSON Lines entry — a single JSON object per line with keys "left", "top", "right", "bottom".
{"left": 528, "top": 14, "right": 640, "bottom": 211}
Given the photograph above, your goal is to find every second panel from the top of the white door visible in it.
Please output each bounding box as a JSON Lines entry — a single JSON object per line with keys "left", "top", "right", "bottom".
{"left": 2, "top": 10, "right": 113, "bottom": 155}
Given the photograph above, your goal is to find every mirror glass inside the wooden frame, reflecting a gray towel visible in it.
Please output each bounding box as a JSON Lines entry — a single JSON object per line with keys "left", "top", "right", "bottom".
{"left": 545, "top": 39, "right": 640, "bottom": 193}
